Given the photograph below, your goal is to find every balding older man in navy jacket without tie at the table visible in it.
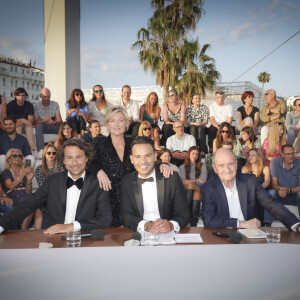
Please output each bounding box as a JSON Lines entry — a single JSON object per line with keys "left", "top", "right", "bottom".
{"left": 201, "top": 148, "right": 299, "bottom": 231}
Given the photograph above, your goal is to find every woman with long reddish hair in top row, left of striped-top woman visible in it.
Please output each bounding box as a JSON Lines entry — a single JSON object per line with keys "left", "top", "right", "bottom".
{"left": 139, "top": 92, "right": 161, "bottom": 150}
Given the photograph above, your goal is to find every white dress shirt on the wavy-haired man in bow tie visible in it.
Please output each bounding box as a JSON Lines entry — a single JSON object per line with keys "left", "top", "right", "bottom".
{"left": 64, "top": 171, "right": 85, "bottom": 231}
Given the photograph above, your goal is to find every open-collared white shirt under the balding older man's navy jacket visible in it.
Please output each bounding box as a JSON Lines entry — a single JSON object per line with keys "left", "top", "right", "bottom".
{"left": 222, "top": 179, "right": 245, "bottom": 228}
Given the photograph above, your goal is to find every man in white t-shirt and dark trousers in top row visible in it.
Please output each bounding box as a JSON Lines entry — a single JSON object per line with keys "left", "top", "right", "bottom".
{"left": 207, "top": 90, "right": 233, "bottom": 152}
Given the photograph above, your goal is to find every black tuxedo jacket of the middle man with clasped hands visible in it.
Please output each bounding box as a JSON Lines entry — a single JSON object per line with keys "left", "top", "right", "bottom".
{"left": 120, "top": 167, "right": 189, "bottom": 230}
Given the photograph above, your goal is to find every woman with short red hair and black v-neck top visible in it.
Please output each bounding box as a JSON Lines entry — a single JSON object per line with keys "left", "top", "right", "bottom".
{"left": 237, "top": 91, "right": 259, "bottom": 133}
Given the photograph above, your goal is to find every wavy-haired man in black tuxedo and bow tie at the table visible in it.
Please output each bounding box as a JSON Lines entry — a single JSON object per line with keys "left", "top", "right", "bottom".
{"left": 0, "top": 139, "right": 112, "bottom": 234}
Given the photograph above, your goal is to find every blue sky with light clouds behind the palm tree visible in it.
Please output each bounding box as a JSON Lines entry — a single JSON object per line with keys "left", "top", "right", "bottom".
{"left": 0, "top": 0, "right": 300, "bottom": 96}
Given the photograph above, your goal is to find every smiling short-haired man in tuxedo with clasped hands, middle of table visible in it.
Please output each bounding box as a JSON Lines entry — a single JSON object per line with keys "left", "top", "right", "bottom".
{"left": 120, "top": 137, "right": 189, "bottom": 234}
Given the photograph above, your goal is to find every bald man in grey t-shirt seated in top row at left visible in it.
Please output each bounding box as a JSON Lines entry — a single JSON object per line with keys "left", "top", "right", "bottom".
{"left": 34, "top": 88, "right": 62, "bottom": 158}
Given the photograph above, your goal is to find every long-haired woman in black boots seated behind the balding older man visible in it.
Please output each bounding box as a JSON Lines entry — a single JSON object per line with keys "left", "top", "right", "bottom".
{"left": 179, "top": 146, "right": 207, "bottom": 226}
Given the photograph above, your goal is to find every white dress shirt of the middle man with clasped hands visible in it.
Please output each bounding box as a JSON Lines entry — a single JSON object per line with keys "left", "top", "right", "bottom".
{"left": 137, "top": 170, "right": 180, "bottom": 231}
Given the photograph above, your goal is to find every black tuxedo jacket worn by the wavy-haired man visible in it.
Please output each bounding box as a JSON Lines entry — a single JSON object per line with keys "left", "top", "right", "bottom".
{"left": 0, "top": 171, "right": 112, "bottom": 231}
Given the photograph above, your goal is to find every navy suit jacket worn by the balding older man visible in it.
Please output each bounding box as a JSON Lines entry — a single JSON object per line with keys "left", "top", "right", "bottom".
{"left": 201, "top": 173, "right": 299, "bottom": 229}
